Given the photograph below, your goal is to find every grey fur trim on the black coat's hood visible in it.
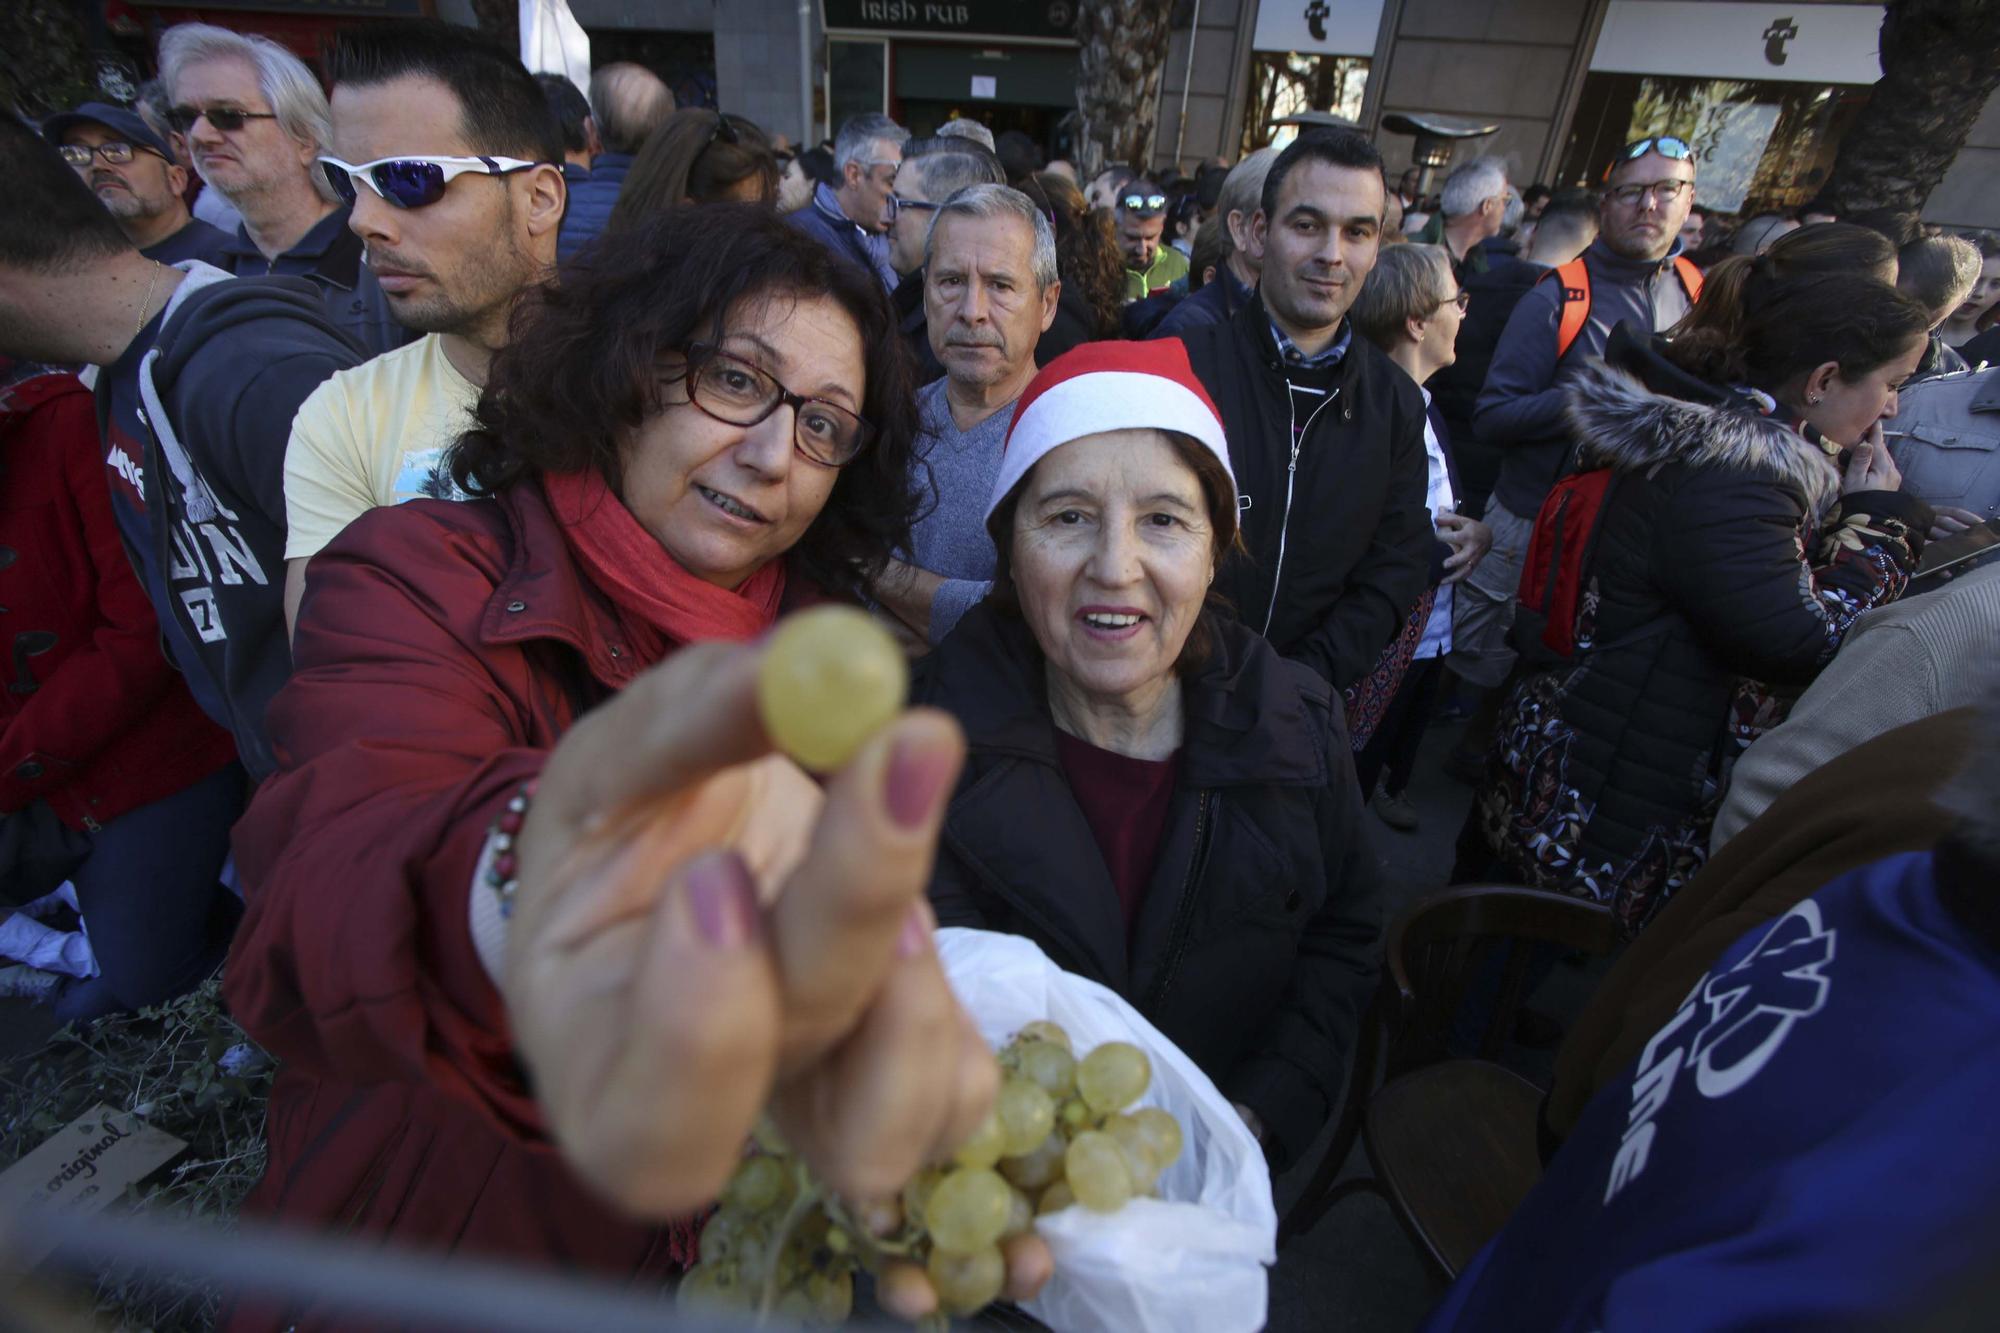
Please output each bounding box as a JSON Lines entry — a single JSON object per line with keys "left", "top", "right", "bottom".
{"left": 1568, "top": 350, "right": 1840, "bottom": 516}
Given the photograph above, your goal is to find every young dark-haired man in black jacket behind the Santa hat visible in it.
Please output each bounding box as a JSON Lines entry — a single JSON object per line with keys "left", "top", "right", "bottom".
{"left": 1184, "top": 130, "right": 1434, "bottom": 689}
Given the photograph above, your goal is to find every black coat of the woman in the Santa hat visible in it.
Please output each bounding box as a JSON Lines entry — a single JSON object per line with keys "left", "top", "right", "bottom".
{"left": 916, "top": 602, "right": 1382, "bottom": 1167}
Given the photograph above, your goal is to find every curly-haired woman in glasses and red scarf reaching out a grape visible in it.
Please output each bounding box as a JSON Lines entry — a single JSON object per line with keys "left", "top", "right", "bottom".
{"left": 228, "top": 206, "right": 1046, "bottom": 1327}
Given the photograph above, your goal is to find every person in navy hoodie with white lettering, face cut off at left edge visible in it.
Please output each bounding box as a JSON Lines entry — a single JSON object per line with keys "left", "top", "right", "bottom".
{"left": 0, "top": 116, "right": 366, "bottom": 779}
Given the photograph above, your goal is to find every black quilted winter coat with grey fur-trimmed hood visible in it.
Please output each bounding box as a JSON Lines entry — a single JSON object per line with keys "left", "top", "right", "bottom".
{"left": 1480, "top": 324, "right": 1930, "bottom": 935}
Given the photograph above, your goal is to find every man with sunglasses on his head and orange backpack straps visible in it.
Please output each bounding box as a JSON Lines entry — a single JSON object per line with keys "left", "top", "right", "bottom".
{"left": 1446, "top": 134, "right": 1700, "bottom": 775}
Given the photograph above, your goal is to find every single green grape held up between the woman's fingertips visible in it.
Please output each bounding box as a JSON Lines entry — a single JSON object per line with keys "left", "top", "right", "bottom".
{"left": 756, "top": 606, "right": 910, "bottom": 773}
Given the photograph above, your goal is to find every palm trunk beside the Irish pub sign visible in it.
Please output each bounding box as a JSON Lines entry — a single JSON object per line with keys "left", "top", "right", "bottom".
{"left": 1076, "top": 0, "right": 1194, "bottom": 180}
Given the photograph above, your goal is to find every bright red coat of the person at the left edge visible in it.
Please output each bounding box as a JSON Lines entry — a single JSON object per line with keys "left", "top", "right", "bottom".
{"left": 0, "top": 372, "right": 236, "bottom": 829}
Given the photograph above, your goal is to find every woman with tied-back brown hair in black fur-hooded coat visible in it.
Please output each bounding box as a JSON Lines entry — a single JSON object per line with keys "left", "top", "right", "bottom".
{"left": 1478, "top": 252, "right": 1930, "bottom": 935}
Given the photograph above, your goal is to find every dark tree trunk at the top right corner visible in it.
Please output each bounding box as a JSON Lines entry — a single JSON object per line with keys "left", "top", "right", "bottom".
{"left": 1822, "top": 0, "right": 2000, "bottom": 214}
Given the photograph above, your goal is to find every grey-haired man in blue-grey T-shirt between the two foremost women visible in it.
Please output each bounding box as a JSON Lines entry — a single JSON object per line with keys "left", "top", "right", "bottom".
{"left": 874, "top": 184, "right": 1062, "bottom": 646}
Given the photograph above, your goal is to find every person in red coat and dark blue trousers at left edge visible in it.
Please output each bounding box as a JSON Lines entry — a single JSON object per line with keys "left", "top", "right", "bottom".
{"left": 0, "top": 358, "right": 244, "bottom": 1021}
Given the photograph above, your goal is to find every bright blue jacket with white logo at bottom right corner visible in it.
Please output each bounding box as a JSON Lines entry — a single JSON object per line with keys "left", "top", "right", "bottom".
{"left": 1424, "top": 853, "right": 2000, "bottom": 1333}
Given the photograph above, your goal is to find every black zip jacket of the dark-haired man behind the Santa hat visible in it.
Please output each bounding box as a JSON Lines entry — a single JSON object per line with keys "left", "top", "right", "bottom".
{"left": 1182, "top": 296, "right": 1436, "bottom": 689}
